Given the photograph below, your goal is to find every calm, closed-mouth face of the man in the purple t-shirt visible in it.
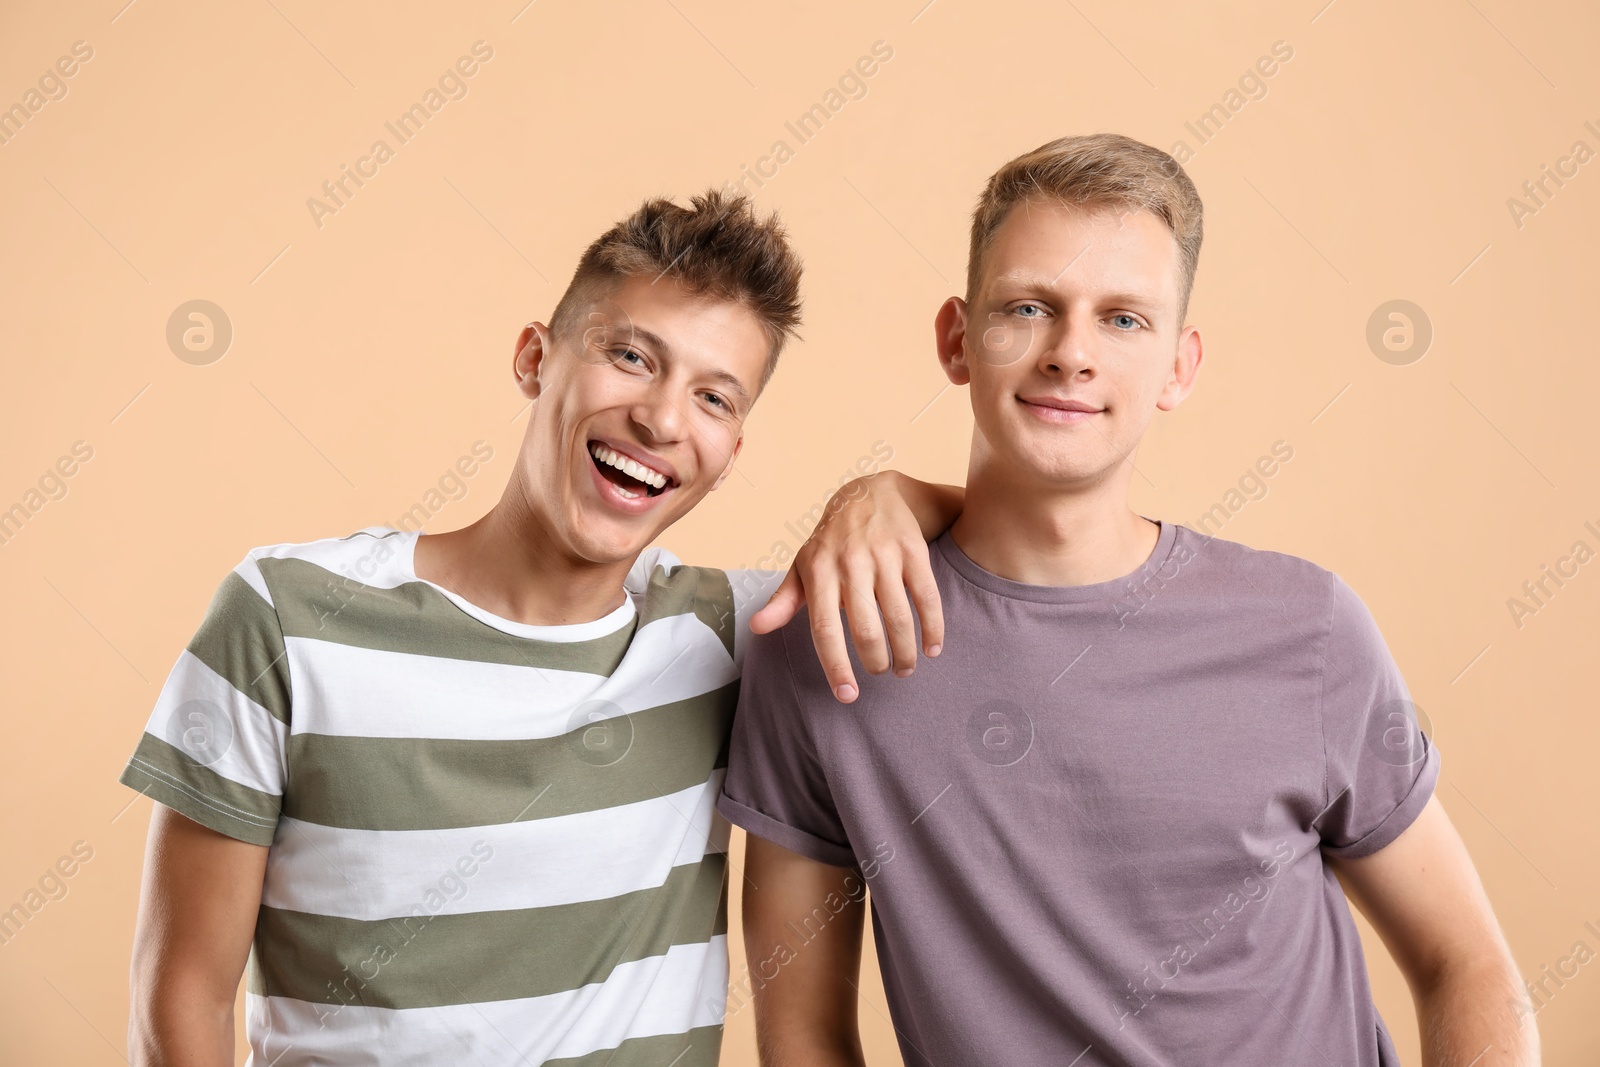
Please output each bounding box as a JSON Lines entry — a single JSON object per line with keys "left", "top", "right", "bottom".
{"left": 936, "top": 202, "right": 1200, "bottom": 493}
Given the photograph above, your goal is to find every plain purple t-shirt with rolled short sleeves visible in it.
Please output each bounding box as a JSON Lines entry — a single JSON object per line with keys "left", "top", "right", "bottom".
{"left": 718, "top": 523, "right": 1438, "bottom": 1067}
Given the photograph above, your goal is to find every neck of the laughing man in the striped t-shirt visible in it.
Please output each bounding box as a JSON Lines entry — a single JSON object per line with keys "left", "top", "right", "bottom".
{"left": 414, "top": 475, "right": 634, "bottom": 625}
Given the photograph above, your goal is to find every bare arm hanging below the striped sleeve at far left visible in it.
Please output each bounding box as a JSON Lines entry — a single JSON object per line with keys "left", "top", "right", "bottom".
{"left": 128, "top": 803, "right": 267, "bottom": 1067}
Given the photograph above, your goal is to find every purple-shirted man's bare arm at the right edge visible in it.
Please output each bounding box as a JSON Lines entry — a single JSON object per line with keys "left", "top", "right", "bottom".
{"left": 1330, "top": 795, "right": 1539, "bottom": 1067}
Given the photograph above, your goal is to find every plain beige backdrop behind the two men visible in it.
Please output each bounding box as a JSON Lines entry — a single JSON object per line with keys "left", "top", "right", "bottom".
{"left": 0, "top": 0, "right": 1600, "bottom": 1064}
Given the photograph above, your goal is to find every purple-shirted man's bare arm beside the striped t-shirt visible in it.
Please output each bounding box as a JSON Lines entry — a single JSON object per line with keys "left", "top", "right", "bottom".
{"left": 744, "top": 833, "right": 866, "bottom": 1067}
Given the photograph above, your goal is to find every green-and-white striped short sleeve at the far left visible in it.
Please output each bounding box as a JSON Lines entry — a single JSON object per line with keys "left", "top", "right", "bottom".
{"left": 118, "top": 557, "right": 290, "bottom": 845}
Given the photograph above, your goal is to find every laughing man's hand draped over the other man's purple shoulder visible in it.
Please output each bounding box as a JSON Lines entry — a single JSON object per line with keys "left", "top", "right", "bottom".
{"left": 750, "top": 470, "right": 966, "bottom": 704}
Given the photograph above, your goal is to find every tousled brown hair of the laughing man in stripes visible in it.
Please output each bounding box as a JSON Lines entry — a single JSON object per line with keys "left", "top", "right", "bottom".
{"left": 550, "top": 189, "right": 800, "bottom": 387}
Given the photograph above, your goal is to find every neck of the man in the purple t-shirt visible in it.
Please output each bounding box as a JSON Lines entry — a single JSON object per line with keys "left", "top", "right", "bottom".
{"left": 950, "top": 448, "right": 1160, "bottom": 585}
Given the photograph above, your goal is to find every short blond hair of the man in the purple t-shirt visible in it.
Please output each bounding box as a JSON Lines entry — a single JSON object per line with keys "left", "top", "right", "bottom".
{"left": 966, "top": 133, "right": 1203, "bottom": 326}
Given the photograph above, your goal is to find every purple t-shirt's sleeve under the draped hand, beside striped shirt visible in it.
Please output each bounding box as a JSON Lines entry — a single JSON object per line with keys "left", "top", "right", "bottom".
{"left": 717, "top": 613, "right": 856, "bottom": 867}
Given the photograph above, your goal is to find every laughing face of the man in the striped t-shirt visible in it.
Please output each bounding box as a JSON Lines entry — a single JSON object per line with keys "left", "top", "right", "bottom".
{"left": 515, "top": 277, "right": 771, "bottom": 563}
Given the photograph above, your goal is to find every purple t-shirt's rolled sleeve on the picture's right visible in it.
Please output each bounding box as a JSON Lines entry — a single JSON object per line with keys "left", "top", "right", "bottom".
{"left": 1315, "top": 574, "right": 1438, "bottom": 859}
